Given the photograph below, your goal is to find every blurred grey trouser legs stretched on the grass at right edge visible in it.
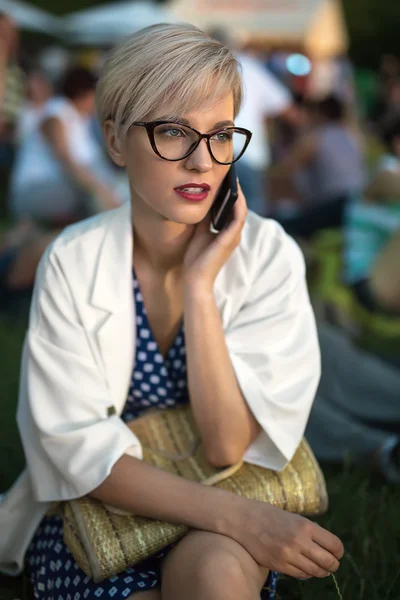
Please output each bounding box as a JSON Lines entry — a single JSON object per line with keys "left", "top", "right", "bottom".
{"left": 306, "top": 323, "right": 400, "bottom": 484}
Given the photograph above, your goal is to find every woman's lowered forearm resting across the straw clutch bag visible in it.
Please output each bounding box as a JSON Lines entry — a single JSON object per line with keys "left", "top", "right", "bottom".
{"left": 91, "top": 455, "right": 245, "bottom": 535}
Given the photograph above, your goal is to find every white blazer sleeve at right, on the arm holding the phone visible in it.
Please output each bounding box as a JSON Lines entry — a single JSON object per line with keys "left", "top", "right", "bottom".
{"left": 226, "top": 221, "right": 320, "bottom": 471}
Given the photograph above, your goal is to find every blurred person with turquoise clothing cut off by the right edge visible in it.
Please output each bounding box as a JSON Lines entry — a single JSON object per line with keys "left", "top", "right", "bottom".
{"left": 344, "top": 119, "right": 400, "bottom": 315}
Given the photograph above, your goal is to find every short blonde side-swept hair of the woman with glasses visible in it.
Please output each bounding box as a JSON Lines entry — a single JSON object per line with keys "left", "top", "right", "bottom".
{"left": 96, "top": 23, "right": 242, "bottom": 136}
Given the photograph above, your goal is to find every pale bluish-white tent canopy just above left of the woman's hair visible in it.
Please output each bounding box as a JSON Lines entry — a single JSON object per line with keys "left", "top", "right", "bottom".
{"left": 63, "top": 2, "right": 175, "bottom": 45}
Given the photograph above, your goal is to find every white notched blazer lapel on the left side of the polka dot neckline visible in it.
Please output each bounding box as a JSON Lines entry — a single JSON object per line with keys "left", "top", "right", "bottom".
{"left": 91, "top": 203, "right": 136, "bottom": 414}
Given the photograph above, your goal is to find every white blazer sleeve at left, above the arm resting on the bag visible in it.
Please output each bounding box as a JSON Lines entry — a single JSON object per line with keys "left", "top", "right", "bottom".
{"left": 17, "top": 244, "right": 142, "bottom": 501}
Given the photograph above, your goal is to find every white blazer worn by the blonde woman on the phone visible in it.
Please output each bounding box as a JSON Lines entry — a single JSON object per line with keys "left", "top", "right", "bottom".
{"left": 0, "top": 204, "right": 320, "bottom": 574}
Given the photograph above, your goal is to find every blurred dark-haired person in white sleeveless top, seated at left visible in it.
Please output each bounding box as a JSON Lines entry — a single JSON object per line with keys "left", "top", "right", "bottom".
{"left": 10, "top": 67, "right": 118, "bottom": 228}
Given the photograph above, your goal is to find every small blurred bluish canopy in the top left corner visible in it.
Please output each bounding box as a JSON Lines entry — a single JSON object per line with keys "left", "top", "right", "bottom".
{"left": 0, "top": 0, "right": 60, "bottom": 34}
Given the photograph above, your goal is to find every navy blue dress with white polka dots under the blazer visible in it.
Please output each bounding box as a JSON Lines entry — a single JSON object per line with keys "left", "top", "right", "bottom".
{"left": 26, "top": 272, "right": 277, "bottom": 600}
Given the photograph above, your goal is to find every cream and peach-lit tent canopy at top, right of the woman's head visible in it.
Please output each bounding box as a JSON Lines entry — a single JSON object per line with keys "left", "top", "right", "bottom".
{"left": 167, "top": 0, "right": 348, "bottom": 57}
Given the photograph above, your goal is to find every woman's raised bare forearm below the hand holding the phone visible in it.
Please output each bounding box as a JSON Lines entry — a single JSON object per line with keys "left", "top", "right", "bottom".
{"left": 184, "top": 289, "right": 260, "bottom": 465}
